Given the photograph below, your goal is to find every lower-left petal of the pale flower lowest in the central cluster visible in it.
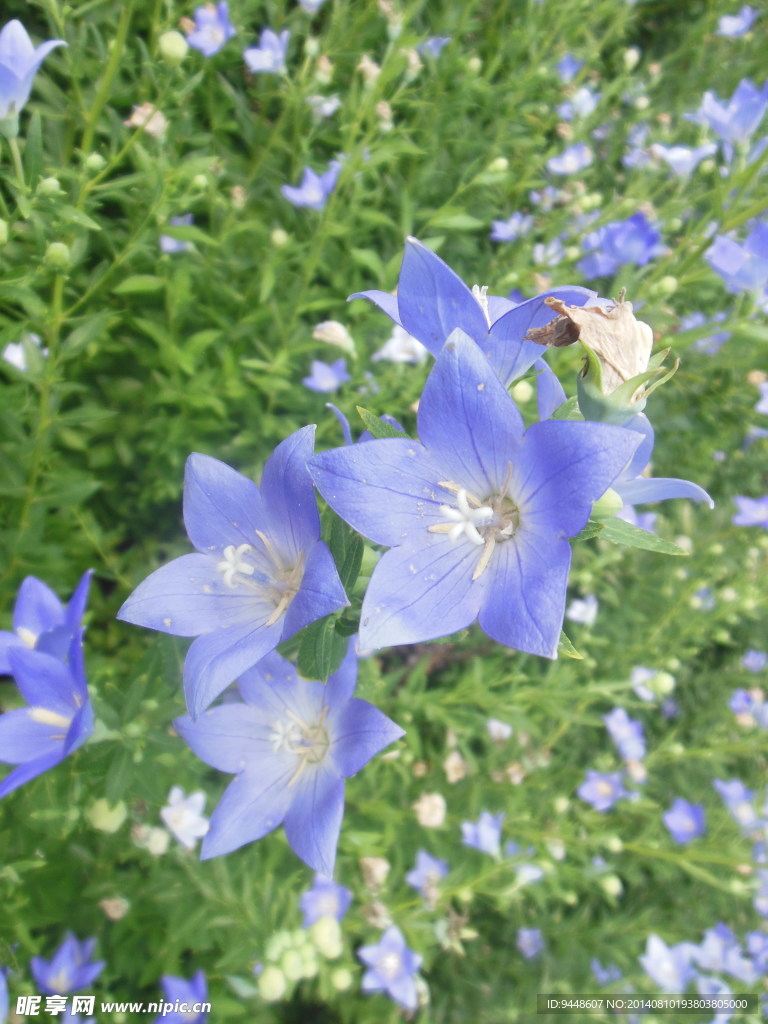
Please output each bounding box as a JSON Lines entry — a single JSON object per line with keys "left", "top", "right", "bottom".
{"left": 200, "top": 757, "right": 295, "bottom": 860}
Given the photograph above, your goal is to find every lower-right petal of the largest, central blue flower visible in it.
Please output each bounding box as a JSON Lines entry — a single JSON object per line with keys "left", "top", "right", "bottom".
{"left": 480, "top": 528, "right": 570, "bottom": 657}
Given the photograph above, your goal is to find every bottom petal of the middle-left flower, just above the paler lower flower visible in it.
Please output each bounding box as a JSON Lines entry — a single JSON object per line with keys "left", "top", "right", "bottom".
{"left": 184, "top": 620, "right": 283, "bottom": 718}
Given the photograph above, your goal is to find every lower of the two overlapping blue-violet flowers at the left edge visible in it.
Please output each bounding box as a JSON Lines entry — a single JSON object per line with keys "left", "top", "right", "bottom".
{"left": 0, "top": 631, "right": 93, "bottom": 797}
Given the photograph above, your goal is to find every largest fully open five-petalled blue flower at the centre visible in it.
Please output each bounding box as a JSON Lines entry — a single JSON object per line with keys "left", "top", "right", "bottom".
{"left": 310, "top": 332, "right": 640, "bottom": 657}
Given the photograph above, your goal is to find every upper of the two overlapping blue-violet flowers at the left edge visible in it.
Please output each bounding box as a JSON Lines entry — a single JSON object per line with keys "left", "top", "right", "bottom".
{"left": 0, "top": 569, "right": 92, "bottom": 676}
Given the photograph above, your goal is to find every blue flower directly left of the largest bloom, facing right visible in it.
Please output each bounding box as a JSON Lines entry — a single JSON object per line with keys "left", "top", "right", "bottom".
{"left": 118, "top": 427, "right": 347, "bottom": 715}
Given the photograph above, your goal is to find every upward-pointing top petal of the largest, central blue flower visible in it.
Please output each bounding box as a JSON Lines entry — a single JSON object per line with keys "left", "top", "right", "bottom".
{"left": 419, "top": 333, "right": 523, "bottom": 500}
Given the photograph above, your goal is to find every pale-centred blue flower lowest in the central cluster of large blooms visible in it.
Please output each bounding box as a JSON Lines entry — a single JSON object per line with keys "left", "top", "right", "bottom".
{"left": 174, "top": 642, "right": 403, "bottom": 877}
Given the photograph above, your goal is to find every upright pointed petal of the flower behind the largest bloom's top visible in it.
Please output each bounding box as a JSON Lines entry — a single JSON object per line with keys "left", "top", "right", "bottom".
{"left": 397, "top": 239, "right": 488, "bottom": 355}
